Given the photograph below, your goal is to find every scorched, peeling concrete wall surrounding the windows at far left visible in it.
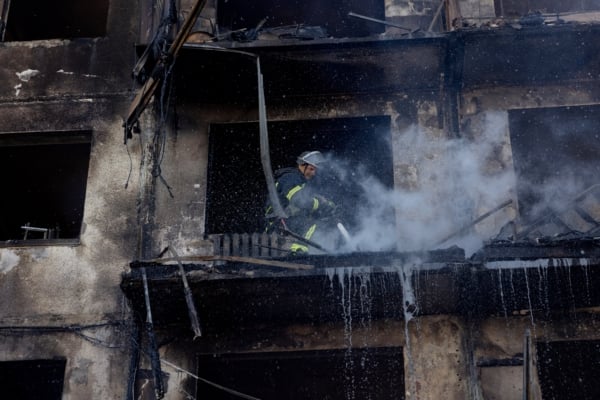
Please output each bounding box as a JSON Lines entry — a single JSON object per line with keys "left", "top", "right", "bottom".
{"left": 0, "top": 0, "right": 140, "bottom": 399}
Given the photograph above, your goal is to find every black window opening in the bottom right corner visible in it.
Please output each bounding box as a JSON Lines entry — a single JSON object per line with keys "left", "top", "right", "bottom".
{"left": 536, "top": 340, "right": 600, "bottom": 400}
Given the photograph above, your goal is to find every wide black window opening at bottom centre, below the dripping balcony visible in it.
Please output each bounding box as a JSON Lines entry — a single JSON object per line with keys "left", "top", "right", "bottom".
{"left": 197, "top": 347, "right": 404, "bottom": 400}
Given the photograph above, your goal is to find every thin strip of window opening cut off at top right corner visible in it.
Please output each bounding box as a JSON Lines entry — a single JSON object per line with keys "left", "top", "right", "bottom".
{"left": 494, "top": 0, "right": 600, "bottom": 17}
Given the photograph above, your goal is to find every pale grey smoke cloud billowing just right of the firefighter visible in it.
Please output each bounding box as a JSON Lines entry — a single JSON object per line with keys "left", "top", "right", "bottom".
{"left": 316, "top": 112, "right": 515, "bottom": 253}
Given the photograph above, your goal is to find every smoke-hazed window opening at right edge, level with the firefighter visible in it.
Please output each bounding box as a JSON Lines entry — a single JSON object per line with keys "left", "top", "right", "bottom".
{"left": 509, "top": 106, "right": 600, "bottom": 225}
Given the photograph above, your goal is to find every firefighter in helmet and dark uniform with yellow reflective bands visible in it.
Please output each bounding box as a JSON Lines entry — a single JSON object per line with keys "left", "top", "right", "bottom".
{"left": 266, "top": 151, "right": 337, "bottom": 254}
